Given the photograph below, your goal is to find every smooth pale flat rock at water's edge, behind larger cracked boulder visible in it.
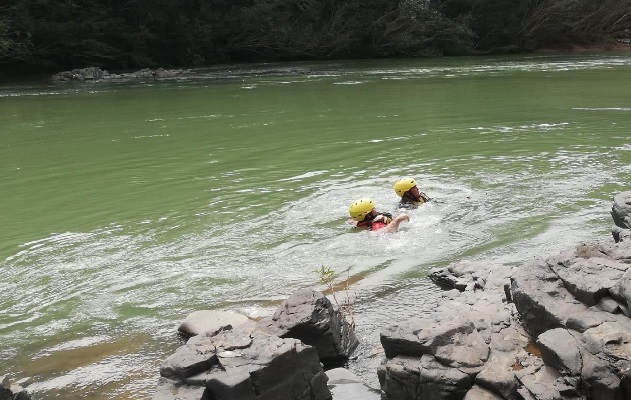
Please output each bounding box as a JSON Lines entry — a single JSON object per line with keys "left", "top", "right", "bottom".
{"left": 178, "top": 310, "right": 250, "bottom": 336}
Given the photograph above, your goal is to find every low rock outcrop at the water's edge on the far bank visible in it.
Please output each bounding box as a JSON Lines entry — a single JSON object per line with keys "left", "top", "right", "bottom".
{"left": 50, "top": 67, "right": 191, "bottom": 82}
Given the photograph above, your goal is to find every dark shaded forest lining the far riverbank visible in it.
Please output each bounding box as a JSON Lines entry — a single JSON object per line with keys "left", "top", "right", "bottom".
{"left": 0, "top": 0, "right": 631, "bottom": 72}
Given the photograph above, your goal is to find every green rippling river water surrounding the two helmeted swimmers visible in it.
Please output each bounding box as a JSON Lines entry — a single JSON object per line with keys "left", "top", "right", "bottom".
{"left": 0, "top": 52, "right": 631, "bottom": 400}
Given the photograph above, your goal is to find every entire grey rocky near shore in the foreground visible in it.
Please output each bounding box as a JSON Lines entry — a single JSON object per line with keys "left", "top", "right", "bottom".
{"left": 147, "top": 192, "right": 631, "bottom": 400}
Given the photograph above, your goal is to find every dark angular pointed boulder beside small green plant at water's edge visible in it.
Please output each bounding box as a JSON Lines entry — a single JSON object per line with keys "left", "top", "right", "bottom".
{"left": 256, "top": 289, "right": 359, "bottom": 363}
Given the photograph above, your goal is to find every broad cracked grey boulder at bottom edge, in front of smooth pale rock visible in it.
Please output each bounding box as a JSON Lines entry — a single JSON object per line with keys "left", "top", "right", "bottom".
{"left": 154, "top": 330, "right": 331, "bottom": 400}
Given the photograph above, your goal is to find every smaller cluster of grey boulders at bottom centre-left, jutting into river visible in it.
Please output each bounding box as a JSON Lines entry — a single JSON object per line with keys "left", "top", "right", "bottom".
{"left": 153, "top": 289, "right": 358, "bottom": 400}
